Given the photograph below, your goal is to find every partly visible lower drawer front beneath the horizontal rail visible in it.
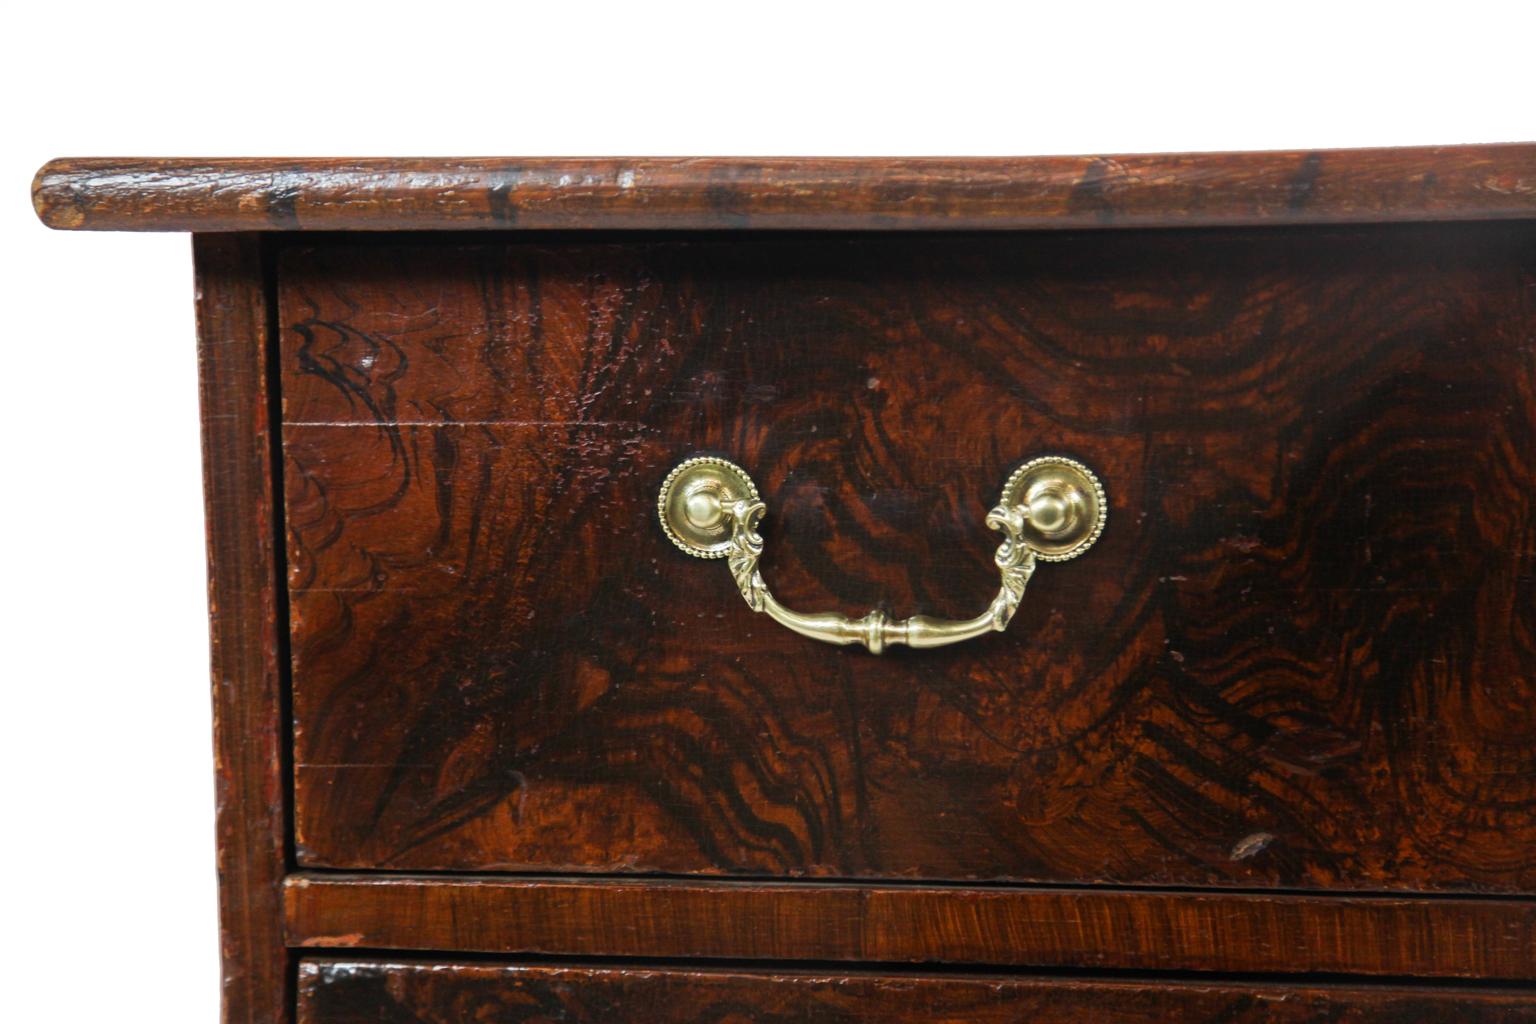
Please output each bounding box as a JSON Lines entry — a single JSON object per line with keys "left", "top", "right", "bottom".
{"left": 298, "top": 960, "right": 1536, "bottom": 1024}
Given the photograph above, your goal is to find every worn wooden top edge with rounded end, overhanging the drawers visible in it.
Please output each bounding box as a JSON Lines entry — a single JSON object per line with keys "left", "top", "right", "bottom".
{"left": 32, "top": 144, "right": 1536, "bottom": 232}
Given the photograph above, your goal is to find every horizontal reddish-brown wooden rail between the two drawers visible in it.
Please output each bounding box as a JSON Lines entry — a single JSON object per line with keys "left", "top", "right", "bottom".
{"left": 286, "top": 874, "right": 1536, "bottom": 978}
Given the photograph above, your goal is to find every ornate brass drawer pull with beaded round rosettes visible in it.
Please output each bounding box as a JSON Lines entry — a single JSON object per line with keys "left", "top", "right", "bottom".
{"left": 656, "top": 456, "right": 1109, "bottom": 654}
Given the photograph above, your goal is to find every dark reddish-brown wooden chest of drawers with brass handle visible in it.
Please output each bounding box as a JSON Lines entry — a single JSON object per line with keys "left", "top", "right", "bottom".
{"left": 34, "top": 146, "right": 1536, "bottom": 1024}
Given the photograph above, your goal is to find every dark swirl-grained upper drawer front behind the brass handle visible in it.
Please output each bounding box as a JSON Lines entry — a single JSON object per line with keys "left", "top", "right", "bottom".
{"left": 280, "top": 224, "right": 1536, "bottom": 890}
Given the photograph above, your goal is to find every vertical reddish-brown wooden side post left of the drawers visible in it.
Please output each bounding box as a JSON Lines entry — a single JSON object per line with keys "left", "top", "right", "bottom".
{"left": 194, "top": 235, "right": 290, "bottom": 1024}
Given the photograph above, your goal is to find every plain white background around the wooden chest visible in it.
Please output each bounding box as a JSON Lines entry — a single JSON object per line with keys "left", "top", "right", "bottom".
{"left": 0, "top": 0, "right": 1536, "bottom": 1021}
